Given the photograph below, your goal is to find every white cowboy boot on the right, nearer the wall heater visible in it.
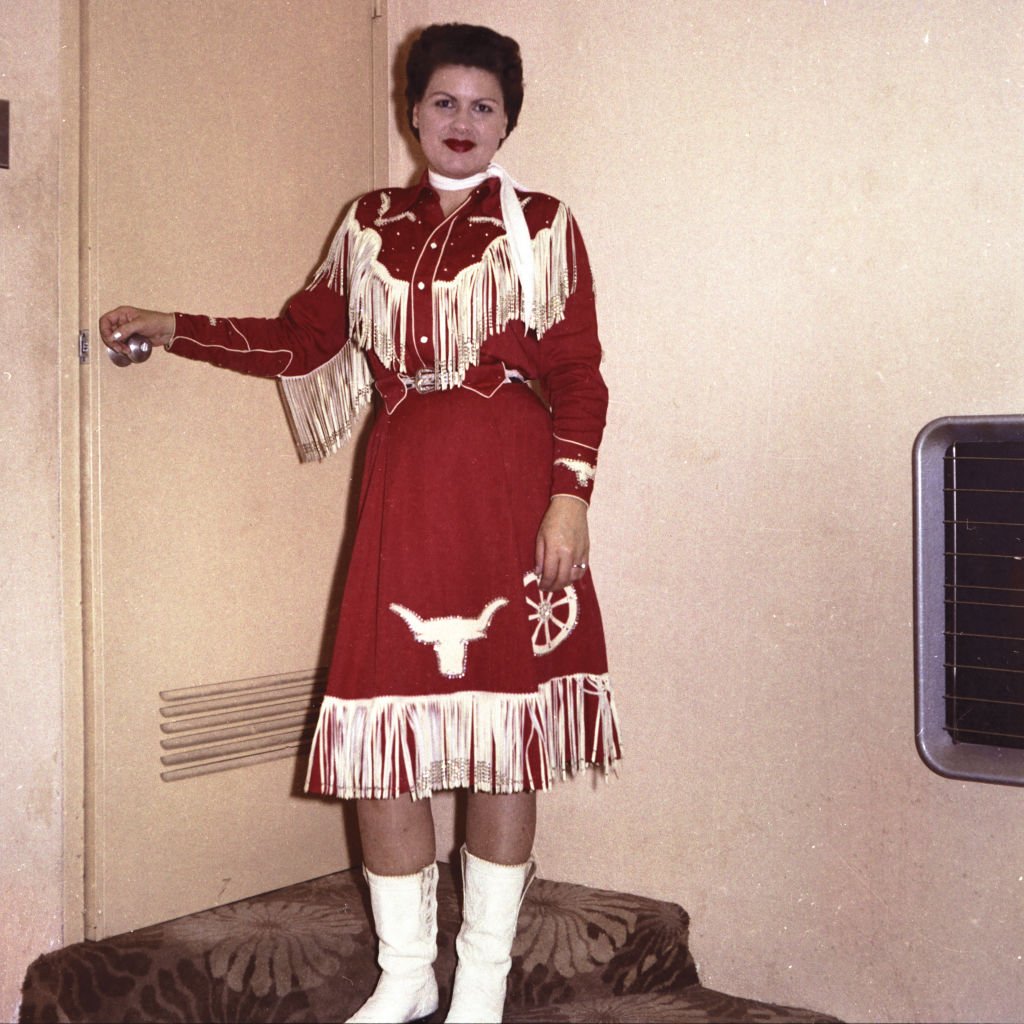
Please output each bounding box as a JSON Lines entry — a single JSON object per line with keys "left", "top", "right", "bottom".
{"left": 445, "top": 847, "right": 537, "bottom": 1024}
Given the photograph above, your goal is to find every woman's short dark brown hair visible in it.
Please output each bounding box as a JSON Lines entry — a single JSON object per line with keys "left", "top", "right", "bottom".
{"left": 406, "top": 24, "right": 522, "bottom": 138}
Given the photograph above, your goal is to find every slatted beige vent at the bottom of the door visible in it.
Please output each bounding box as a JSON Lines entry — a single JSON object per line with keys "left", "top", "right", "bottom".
{"left": 160, "top": 670, "right": 327, "bottom": 782}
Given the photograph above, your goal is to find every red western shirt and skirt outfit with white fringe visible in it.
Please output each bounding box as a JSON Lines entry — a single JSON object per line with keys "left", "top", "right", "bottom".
{"left": 169, "top": 178, "right": 620, "bottom": 798}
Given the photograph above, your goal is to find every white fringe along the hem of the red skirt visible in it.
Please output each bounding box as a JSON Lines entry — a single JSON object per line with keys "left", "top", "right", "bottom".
{"left": 306, "top": 674, "right": 620, "bottom": 799}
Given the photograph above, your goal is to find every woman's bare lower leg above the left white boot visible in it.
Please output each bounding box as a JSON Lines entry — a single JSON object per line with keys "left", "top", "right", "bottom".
{"left": 355, "top": 793, "right": 437, "bottom": 874}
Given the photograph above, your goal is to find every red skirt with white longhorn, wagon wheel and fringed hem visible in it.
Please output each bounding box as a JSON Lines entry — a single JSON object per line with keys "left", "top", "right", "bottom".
{"left": 306, "top": 383, "right": 620, "bottom": 798}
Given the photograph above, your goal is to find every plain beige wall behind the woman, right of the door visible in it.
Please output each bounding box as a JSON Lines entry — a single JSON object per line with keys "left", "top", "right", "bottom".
{"left": 389, "top": 0, "right": 1024, "bottom": 1021}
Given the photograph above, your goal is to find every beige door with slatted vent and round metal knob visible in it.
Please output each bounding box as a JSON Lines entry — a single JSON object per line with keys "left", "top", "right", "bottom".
{"left": 81, "top": 0, "right": 386, "bottom": 938}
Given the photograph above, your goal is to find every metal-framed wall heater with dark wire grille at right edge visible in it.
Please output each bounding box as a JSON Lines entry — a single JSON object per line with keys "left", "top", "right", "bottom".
{"left": 914, "top": 416, "right": 1024, "bottom": 784}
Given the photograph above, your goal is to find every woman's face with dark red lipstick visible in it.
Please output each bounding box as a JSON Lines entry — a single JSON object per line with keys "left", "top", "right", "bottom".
{"left": 413, "top": 65, "right": 508, "bottom": 178}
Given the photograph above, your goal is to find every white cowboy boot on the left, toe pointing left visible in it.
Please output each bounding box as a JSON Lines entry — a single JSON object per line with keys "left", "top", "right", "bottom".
{"left": 346, "top": 864, "right": 437, "bottom": 1024}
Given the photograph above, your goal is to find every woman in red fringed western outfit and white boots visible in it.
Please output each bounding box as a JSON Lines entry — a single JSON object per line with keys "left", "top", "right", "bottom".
{"left": 100, "top": 25, "right": 620, "bottom": 1021}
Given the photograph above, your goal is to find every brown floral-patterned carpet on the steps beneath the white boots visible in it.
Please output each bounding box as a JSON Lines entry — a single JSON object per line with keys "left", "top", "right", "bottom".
{"left": 20, "top": 864, "right": 835, "bottom": 1024}
